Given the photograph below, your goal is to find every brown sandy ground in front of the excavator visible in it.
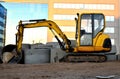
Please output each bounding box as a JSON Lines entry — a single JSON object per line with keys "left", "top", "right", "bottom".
{"left": 0, "top": 61, "right": 120, "bottom": 79}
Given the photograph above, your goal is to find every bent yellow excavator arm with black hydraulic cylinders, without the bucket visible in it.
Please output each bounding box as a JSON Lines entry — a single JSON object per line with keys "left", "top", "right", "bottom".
{"left": 16, "top": 19, "right": 73, "bottom": 53}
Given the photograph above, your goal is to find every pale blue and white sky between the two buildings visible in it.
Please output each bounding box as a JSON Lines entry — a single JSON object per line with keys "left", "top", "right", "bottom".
{"left": 1, "top": 2, "right": 48, "bottom": 45}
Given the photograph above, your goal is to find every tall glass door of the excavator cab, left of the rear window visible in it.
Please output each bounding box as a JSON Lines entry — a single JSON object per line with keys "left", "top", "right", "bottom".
{"left": 80, "top": 14, "right": 93, "bottom": 46}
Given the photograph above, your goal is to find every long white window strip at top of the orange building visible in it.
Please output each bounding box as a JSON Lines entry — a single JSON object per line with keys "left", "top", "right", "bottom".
{"left": 54, "top": 3, "right": 114, "bottom": 10}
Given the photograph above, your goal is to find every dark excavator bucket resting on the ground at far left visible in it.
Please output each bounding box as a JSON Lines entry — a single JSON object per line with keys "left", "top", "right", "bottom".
{"left": 1, "top": 45, "right": 22, "bottom": 63}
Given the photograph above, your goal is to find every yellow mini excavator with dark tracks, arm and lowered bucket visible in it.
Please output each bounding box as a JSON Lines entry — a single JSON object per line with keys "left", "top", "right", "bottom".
{"left": 2, "top": 13, "right": 112, "bottom": 63}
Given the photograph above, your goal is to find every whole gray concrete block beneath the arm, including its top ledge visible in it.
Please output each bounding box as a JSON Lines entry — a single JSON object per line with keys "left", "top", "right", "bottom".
{"left": 23, "top": 44, "right": 52, "bottom": 64}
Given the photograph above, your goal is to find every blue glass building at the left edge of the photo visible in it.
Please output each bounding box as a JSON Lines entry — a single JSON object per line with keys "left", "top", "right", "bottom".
{"left": 0, "top": 4, "right": 7, "bottom": 47}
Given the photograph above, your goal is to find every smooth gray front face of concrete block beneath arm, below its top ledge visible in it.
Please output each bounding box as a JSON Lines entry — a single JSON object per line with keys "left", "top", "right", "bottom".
{"left": 25, "top": 48, "right": 50, "bottom": 64}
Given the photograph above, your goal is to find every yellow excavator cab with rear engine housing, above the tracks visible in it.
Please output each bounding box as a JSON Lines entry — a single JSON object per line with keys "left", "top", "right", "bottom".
{"left": 75, "top": 13, "right": 111, "bottom": 53}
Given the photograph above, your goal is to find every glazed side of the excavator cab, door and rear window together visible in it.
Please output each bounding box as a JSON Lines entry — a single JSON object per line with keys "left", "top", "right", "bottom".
{"left": 80, "top": 14, "right": 105, "bottom": 46}
